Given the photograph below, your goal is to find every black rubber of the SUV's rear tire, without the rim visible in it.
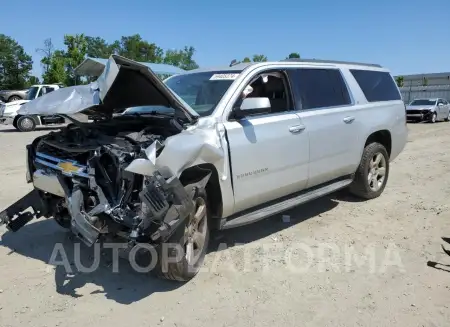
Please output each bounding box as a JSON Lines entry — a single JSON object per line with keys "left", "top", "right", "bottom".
{"left": 349, "top": 142, "right": 389, "bottom": 200}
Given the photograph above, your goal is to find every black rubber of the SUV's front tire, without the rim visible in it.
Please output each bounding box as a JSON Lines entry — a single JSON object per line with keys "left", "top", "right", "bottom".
{"left": 154, "top": 190, "right": 210, "bottom": 282}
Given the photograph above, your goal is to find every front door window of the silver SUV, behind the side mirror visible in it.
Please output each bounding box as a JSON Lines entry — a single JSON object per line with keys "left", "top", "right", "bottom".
{"left": 234, "top": 71, "right": 292, "bottom": 113}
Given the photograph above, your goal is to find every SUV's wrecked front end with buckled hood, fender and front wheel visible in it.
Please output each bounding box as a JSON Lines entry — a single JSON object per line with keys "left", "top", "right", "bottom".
{"left": 0, "top": 56, "right": 229, "bottom": 280}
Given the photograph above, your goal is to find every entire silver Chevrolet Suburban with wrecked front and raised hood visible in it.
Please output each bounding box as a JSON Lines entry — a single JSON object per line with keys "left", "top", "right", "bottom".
{"left": 0, "top": 56, "right": 407, "bottom": 281}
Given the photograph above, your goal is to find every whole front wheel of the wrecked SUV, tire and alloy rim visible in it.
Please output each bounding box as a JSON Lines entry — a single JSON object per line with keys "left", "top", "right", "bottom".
{"left": 155, "top": 190, "right": 210, "bottom": 282}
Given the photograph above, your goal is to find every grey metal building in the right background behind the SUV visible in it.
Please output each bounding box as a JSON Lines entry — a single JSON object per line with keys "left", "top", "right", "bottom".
{"left": 395, "top": 72, "right": 450, "bottom": 103}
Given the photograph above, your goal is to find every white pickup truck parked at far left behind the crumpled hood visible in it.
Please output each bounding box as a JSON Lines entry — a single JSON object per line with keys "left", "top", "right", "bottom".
{"left": 0, "top": 84, "right": 65, "bottom": 132}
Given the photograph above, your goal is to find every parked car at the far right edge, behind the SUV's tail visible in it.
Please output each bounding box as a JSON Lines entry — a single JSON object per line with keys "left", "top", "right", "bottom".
{"left": 406, "top": 98, "right": 450, "bottom": 123}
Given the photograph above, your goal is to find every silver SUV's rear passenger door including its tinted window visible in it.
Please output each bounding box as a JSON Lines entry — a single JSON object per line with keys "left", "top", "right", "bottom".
{"left": 290, "top": 68, "right": 360, "bottom": 187}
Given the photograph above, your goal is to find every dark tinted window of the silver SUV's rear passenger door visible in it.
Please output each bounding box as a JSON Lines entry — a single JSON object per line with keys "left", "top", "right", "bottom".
{"left": 293, "top": 68, "right": 351, "bottom": 109}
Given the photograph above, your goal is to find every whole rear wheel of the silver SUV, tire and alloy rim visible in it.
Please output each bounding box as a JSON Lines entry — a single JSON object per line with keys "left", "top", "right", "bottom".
{"left": 350, "top": 142, "right": 389, "bottom": 200}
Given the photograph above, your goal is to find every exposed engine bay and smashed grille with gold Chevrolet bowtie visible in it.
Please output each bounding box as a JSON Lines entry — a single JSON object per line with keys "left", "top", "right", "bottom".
{"left": 13, "top": 116, "right": 209, "bottom": 245}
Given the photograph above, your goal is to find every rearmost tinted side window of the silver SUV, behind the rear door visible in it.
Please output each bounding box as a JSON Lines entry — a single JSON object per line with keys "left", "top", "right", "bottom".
{"left": 350, "top": 69, "right": 401, "bottom": 102}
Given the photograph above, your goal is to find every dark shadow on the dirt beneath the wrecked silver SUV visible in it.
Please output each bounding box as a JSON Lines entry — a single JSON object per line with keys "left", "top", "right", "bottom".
{"left": 0, "top": 193, "right": 351, "bottom": 304}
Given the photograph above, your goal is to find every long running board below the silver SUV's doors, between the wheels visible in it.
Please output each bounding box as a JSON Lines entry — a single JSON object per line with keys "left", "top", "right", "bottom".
{"left": 221, "top": 179, "right": 353, "bottom": 229}
